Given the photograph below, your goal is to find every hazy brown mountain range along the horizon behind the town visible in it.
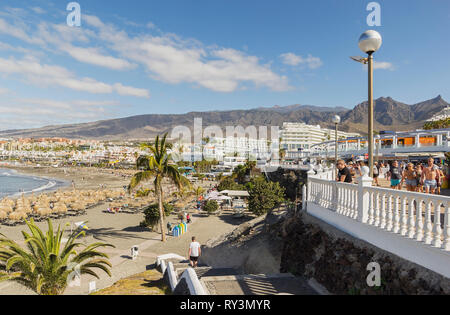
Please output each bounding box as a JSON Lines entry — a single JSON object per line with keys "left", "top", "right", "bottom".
{"left": 0, "top": 95, "right": 450, "bottom": 140}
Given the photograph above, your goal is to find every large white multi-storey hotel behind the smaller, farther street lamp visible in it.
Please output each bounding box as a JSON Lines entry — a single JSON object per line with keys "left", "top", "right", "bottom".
{"left": 280, "top": 122, "right": 360, "bottom": 157}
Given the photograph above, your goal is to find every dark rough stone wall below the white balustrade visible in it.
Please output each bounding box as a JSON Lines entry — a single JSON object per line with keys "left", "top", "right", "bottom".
{"left": 280, "top": 213, "right": 450, "bottom": 295}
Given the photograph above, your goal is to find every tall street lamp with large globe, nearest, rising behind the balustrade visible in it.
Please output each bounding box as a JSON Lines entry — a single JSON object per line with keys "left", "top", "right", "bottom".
{"left": 351, "top": 30, "right": 383, "bottom": 177}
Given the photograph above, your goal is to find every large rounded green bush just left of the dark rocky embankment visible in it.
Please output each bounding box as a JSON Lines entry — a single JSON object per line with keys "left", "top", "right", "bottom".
{"left": 248, "top": 176, "right": 285, "bottom": 215}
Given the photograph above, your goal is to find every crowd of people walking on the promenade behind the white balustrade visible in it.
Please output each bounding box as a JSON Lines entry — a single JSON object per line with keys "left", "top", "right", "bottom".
{"left": 336, "top": 157, "right": 445, "bottom": 195}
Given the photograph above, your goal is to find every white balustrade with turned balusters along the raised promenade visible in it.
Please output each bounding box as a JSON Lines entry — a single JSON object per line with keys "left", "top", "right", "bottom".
{"left": 303, "top": 175, "right": 450, "bottom": 251}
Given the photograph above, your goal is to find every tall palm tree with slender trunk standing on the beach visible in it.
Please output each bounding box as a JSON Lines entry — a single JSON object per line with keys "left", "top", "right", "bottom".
{"left": 128, "top": 133, "right": 190, "bottom": 242}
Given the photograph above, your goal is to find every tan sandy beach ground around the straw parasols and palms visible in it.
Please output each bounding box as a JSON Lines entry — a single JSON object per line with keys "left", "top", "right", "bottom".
{"left": 0, "top": 167, "right": 252, "bottom": 295}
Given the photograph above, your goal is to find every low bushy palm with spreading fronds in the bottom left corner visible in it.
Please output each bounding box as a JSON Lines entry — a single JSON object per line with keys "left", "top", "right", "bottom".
{"left": 0, "top": 219, "right": 114, "bottom": 295}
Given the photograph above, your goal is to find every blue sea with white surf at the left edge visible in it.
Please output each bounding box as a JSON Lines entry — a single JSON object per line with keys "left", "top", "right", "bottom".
{"left": 0, "top": 168, "right": 67, "bottom": 198}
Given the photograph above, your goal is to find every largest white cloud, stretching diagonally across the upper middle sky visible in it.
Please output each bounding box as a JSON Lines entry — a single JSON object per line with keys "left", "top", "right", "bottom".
{"left": 79, "top": 16, "right": 291, "bottom": 92}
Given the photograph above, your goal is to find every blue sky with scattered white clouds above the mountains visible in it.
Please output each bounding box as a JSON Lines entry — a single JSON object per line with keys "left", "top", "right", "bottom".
{"left": 0, "top": 0, "right": 450, "bottom": 130}
